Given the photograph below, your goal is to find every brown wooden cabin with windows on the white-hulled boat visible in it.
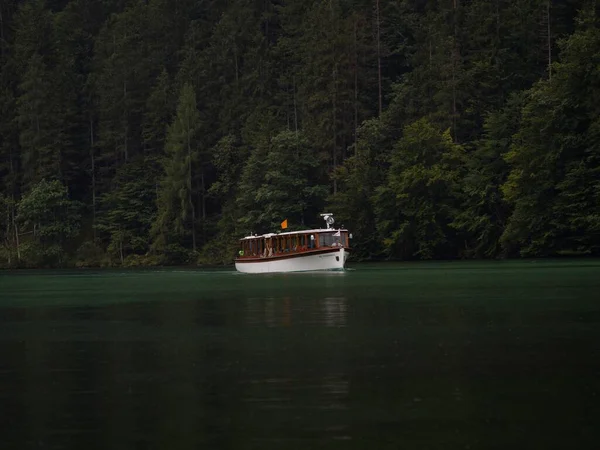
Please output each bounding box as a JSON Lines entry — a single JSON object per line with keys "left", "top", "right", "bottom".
{"left": 238, "top": 228, "right": 349, "bottom": 259}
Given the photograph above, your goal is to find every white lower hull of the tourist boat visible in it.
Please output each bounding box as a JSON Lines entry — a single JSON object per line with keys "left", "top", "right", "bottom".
{"left": 235, "top": 248, "right": 348, "bottom": 273}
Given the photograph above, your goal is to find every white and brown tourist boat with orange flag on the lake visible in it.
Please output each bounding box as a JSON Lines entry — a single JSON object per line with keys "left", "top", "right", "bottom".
{"left": 235, "top": 213, "right": 352, "bottom": 273}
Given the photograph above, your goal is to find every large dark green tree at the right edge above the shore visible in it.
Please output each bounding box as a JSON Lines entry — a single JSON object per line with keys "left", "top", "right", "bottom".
{"left": 502, "top": 11, "right": 600, "bottom": 255}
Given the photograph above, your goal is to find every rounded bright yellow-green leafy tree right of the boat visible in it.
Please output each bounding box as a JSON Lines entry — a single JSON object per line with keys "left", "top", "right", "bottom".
{"left": 376, "top": 119, "right": 464, "bottom": 259}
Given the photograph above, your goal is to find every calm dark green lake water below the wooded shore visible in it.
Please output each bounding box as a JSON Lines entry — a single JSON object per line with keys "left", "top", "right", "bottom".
{"left": 0, "top": 261, "right": 600, "bottom": 450}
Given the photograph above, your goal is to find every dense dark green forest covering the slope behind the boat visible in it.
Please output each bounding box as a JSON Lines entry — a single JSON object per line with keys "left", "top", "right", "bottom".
{"left": 0, "top": 0, "right": 600, "bottom": 267}
